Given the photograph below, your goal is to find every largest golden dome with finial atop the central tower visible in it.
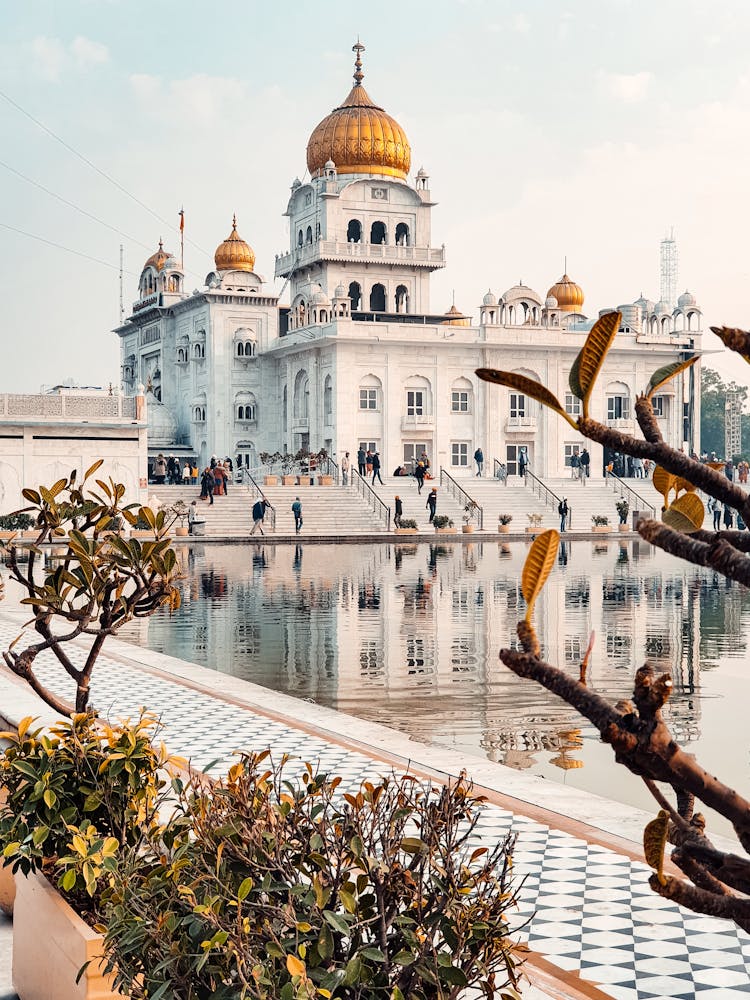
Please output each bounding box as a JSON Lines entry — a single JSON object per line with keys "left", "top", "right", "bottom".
{"left": 307, "top": 42, "right": 411, "bottom": 180}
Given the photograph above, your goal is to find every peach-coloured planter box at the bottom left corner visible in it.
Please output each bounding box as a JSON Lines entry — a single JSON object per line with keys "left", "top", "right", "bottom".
{"left": 13, "top": 875, "right": 123, "bottom": 1000}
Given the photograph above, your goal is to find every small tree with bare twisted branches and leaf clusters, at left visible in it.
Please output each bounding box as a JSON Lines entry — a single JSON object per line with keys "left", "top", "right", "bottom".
{"left": 3, "top": 461, "right": 180, "bottom": 715}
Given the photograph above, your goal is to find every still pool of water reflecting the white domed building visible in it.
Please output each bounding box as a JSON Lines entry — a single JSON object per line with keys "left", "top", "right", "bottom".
{"left": 125, "top": 538, "right": 750, "bottom": 828}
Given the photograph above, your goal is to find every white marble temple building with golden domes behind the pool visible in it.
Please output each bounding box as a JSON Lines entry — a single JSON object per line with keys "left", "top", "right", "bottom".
{"left": 116, "top": 39, "right": 701, "bottom": 477}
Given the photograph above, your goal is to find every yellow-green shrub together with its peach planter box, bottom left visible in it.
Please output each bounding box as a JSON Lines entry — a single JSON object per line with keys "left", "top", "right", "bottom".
{"left": 0, "top": 713, "right": 169, "bottom": 1000}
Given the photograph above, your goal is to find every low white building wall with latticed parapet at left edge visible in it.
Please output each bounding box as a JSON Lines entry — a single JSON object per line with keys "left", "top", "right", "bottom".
{"left": 0, "top": 392, "right": 148, "bottom": 514}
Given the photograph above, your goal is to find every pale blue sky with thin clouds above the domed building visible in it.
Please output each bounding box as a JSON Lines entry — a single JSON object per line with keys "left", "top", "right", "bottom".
{"left": 0, "top": 0, "right": 750, "bottom": 391}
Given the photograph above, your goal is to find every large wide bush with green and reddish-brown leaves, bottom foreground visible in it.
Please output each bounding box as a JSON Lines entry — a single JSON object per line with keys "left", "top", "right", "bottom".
{"left": 103, "top": 751, "right": 522, "bottom": 1000}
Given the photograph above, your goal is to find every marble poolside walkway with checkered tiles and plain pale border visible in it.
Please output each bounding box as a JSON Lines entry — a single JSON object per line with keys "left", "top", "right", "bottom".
{"left": 0, "top": 614, "right": 750, "bottom": 1000}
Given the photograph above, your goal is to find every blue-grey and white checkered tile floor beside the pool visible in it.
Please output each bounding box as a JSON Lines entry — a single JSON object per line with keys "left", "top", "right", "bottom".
{"left": 0, "top": 622, "right": 750, "bottom": 1000}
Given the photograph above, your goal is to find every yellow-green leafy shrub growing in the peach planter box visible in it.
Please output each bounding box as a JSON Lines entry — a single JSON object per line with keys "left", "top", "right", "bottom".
{"left": 0, "top": 713, "right": 168, "bottom": 908}
